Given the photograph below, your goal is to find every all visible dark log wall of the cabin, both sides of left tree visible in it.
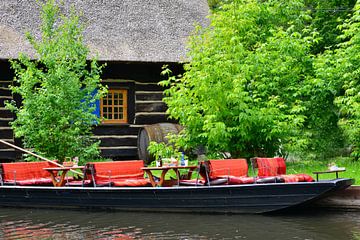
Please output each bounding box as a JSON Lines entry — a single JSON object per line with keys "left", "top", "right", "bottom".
{"left": 0, "top": 61, "right": 182, "bottom": 162}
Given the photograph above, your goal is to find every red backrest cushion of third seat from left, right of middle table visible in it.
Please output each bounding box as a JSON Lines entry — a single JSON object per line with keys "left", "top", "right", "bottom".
{"left": 209, "top": 159, "right": 248, "bottom": 179}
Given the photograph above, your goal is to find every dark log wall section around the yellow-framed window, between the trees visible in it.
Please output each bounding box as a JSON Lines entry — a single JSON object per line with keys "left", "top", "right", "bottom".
{"left": 94, "top": 62, "right": 182, "bottom": 160}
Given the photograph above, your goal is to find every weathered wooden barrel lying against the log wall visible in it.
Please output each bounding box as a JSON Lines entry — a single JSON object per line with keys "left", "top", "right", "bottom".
{"left": 137, "top": 123, "right": 182, "bottom": 164}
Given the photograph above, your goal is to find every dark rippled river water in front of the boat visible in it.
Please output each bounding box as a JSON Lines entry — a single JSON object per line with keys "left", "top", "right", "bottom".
{"left": 0, "top": 208, "right": 360, "bottom": 240}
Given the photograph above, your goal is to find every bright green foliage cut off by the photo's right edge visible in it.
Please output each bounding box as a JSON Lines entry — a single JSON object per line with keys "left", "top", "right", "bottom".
{"left": 316, "top": 4, "right": 360, "bottom": 159}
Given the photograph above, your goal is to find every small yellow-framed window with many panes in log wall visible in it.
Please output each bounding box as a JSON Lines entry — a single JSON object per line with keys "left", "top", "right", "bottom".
{"left": 100, "top": 89, "right": 128, "bottom": 124}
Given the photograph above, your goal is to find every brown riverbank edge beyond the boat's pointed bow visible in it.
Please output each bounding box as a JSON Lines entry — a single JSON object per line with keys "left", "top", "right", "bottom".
{"left": 316, "top": 185, "right": 360, "bottom": 210}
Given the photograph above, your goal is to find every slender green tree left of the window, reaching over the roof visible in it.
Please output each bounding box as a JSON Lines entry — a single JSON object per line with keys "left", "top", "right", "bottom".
{"left": 7, "top": 0, "right": 104, "bottom": 164}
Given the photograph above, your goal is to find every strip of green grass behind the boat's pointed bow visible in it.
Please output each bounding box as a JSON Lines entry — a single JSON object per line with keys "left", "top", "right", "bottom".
{"left": 286, "top": 158, "right": 360, "bottom": 184}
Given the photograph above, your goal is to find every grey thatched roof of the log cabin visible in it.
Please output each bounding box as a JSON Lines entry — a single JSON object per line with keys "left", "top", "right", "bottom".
{"left": 0, "top": 0, "right": 209, "bottom": 62}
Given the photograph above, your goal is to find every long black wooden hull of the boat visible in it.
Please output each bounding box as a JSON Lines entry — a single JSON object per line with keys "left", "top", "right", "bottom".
{"left": 0, "top": 179, "right": 353, "bottom": 213}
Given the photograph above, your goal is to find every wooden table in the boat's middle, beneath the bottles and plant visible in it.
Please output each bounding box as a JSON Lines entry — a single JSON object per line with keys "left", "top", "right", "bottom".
{"left": 141, "top": 166, "right": 198, "bottom": 187}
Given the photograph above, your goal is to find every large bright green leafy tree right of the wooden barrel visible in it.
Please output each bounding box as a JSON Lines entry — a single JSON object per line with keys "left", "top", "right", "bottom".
{"left": 162, "top": 0, "right": 317, "bottom": 157}
